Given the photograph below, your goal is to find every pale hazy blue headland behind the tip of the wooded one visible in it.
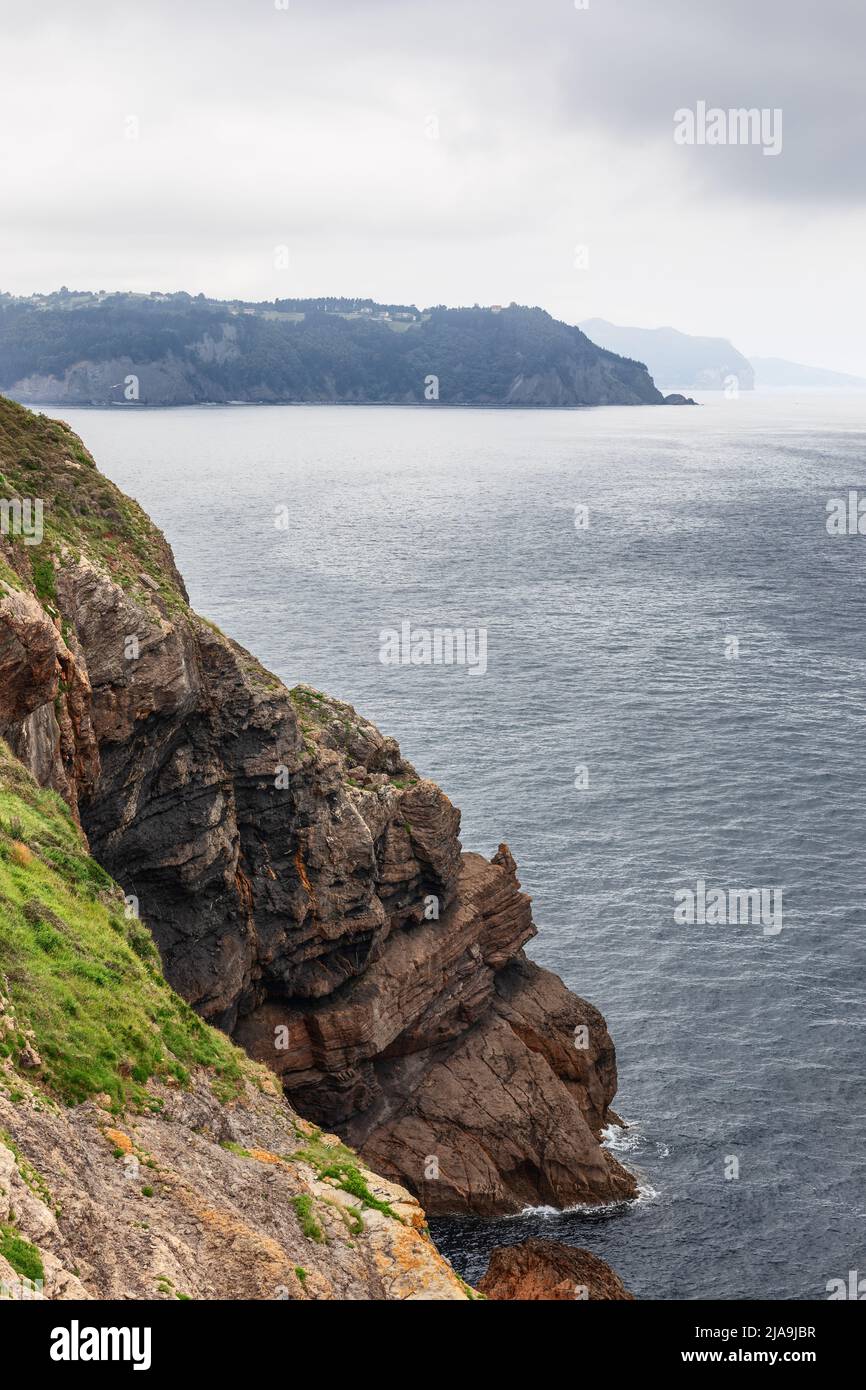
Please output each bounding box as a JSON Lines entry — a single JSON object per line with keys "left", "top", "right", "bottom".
{"left": 580, "top": 318, "right": 755, "bottom": 391}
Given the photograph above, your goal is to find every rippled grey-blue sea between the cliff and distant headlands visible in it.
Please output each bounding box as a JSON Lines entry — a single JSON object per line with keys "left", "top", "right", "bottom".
{"left": 57, "top": 393, "right": 866, "bottom": 1300}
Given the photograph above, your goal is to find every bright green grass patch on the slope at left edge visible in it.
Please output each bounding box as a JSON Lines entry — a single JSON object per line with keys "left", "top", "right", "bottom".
{"left": 0, "top": 742, "right": 252, "bottom": 1109}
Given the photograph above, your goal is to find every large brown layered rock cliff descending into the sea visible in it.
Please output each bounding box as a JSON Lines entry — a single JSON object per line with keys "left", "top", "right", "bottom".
{"left": 0, "top": 403, "right": 635, "bottom": 1213}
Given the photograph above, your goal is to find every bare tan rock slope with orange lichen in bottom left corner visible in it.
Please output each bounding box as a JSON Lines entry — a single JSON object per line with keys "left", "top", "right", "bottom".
{"left": 0, "top": 1080, "right": 473, "bottom": 1301}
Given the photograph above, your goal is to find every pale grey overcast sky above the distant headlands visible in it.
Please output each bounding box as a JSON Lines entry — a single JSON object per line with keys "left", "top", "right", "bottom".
{"left": 0, "top": 0, "right": 866, "bottom": 375}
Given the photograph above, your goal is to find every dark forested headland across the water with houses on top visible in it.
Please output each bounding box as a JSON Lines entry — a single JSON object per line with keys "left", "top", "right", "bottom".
{"left": 0, "top": 288, "right": 663, "bottom": 406}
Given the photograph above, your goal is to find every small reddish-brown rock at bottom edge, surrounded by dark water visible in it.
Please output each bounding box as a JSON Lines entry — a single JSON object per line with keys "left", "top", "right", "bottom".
{"left": 478, "top": 1240, "right": 634, "bottom": 1302}
